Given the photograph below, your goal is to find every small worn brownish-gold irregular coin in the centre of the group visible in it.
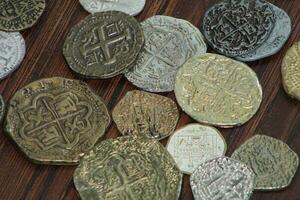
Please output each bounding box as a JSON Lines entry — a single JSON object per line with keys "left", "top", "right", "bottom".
{"left": 112, "top": 90, "right": 179, "bottom": 140}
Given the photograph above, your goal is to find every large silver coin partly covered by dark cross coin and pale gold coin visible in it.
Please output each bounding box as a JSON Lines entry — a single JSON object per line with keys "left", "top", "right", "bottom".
{"left": 125, "top": 16, "right": 207, "bottom": 92}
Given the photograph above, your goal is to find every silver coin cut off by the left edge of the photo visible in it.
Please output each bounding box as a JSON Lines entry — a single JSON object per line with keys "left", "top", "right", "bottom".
{"left": 0, "top": 31, "right": 26, "bottom": 79}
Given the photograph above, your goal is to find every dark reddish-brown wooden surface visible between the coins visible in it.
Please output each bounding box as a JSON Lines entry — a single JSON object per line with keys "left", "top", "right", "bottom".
{"left": 0, "top": 0, "right": 300, "bottom": 200}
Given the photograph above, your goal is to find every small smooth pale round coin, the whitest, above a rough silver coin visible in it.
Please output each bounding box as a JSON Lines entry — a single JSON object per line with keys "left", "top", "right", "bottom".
{"left": 167, "top": 124, "right": 227, "bottom": 174}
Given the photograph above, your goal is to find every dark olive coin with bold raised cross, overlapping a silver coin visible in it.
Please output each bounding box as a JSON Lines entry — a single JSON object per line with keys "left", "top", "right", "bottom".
{"left": 63, "top": 11, "right": 144, "bottom": 78}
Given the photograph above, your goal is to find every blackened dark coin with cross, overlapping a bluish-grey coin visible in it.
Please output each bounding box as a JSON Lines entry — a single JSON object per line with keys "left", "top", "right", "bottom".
{"left": 202, "top": 0, "right": 276, "bottom": 57}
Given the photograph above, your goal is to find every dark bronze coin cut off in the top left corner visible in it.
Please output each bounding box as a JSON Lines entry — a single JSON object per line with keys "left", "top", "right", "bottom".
{"left": 0, "top": 0, "right": 46, "bottom": 31}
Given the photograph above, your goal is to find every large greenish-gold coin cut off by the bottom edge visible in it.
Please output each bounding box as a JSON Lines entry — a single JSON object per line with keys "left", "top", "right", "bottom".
{"left": 74, "top": 136, "right": 182, "bottom": 200}
